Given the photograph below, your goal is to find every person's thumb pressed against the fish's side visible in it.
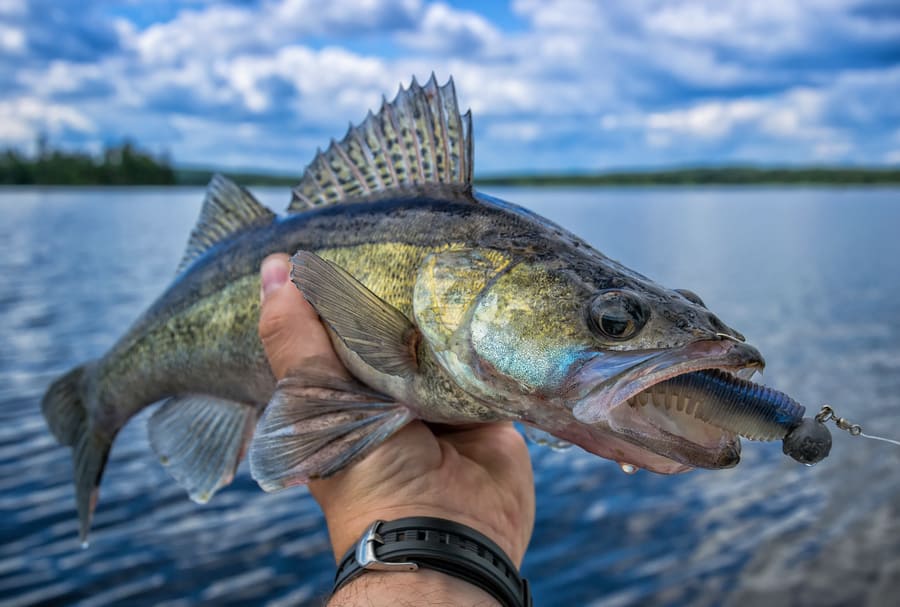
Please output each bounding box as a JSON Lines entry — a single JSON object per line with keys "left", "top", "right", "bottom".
{"left": 259, "top": 253, "right": 344, "bottom": 379}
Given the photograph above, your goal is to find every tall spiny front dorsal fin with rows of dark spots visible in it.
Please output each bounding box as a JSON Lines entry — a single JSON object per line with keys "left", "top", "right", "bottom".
{"left": 288, "top": 74, "right": 472, "bottom": 213}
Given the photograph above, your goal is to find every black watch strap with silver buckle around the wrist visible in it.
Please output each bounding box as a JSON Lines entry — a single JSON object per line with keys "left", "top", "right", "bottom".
{"left": 334, "top": 516, "right": 532, "bottom": 607}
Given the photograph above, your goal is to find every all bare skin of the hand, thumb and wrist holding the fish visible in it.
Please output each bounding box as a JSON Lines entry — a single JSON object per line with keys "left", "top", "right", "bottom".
{"left": 259, "top": 254, "right": 535, "bottom": 605}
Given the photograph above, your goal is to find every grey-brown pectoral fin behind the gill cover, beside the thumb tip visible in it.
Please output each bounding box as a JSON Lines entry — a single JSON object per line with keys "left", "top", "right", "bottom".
{"left": 291, "top": 251, "right": 418, "bottom": 377}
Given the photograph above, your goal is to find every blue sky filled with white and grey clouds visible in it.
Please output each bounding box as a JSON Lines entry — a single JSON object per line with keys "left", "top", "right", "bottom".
{"left": 0, "top": 0, "right": 900, "bottom": 175}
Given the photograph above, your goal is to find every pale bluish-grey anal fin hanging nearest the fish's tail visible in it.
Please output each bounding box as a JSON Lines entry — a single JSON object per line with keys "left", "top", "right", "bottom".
{"left": 149, "top": 394, "right": 257, "bottom": 503}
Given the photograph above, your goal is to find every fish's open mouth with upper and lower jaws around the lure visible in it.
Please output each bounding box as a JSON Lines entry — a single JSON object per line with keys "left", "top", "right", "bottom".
{"left": 573, "top": 339, "right": 765, "bottom": 473}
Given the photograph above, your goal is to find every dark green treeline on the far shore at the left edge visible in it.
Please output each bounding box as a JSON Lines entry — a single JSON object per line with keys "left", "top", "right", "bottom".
{"left": 0, "top": 138, "right": 176, "bottom": 185}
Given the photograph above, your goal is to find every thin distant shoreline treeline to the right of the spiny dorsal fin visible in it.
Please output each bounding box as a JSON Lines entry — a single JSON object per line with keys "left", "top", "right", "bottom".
{"left": 476, "top": 167, "right": 900, "bottom": 186}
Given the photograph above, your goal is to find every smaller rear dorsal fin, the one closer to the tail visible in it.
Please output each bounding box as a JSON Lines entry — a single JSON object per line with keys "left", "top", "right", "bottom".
{"left": 178, "top": 174, "right": 275, "bottom": 273}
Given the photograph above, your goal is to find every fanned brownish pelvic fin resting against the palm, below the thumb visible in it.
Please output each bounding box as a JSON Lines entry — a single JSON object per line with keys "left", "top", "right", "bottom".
{"left": 250, "top": 374, "right": 413, "bottom": 491}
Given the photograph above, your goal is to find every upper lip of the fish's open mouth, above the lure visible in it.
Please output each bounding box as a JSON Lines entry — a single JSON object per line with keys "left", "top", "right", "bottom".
{"left": 572, "top": 339, "right": 765, "bottom": 424}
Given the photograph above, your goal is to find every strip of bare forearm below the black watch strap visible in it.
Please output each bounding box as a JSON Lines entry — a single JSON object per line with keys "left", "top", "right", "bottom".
{"left": 328, "top": 569, "right": 500, "bottom": 607}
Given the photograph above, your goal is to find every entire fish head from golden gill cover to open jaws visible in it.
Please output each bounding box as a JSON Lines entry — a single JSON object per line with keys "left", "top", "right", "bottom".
{"left": 419, "top": 251, "right": 764, "bottom": 472}
